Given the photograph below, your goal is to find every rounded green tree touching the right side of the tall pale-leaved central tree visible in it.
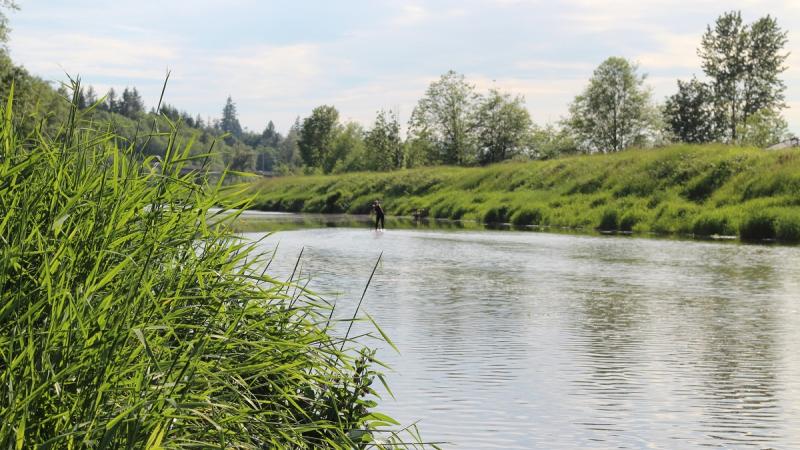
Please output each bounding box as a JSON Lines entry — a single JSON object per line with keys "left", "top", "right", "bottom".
{"left": 476, "top": 89, "right": 533, "bottom": 164}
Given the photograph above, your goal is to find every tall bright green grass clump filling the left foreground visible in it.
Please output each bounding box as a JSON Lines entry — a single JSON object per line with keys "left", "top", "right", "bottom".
{"left": 0, "top": 87, "right": 424, "bottom": 449}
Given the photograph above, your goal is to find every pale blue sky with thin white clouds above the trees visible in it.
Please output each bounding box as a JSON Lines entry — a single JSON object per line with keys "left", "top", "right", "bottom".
{"left": 7, "top": 0, "right": 800, "bottom": 134}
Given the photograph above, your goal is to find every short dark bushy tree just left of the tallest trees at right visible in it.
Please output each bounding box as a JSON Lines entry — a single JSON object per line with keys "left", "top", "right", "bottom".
{"left": 664, "top": 78, "right": 721, "bottom": 144}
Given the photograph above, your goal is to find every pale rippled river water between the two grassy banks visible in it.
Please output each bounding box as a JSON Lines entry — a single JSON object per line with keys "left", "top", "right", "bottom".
{"left": 245, "top": 220, "right": 800, "bottom": 449}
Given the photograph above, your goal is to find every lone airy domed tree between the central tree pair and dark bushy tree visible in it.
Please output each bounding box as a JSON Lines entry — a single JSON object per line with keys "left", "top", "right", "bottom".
{"left": 567, "top": 57, "right": 655, "bottom": 153}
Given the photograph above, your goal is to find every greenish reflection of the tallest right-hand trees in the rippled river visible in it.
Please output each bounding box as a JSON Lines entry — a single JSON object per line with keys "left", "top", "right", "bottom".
{"left": 680, "top": 253, "right": 784, "bottom": 446}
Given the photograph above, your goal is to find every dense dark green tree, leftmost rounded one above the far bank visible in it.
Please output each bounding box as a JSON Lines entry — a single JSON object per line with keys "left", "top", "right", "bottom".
{"left": 297, "top": 105, "right": 340, "bottom": 173}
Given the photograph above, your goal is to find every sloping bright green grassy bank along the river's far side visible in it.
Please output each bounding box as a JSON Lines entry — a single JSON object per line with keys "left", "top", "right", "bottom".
{"left": 249, "top": 145, "right": 800, "bottom": 242}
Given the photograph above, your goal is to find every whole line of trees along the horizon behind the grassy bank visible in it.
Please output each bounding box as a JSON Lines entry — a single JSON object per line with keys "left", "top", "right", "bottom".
{"left": 0, "top": 8, "right": 788, "bottom": 173}
